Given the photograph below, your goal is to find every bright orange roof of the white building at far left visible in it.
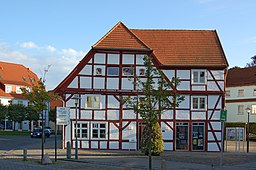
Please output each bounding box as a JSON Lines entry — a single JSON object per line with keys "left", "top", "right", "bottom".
{"left": 0, "top": 62, "right": 39, "bottom": 86}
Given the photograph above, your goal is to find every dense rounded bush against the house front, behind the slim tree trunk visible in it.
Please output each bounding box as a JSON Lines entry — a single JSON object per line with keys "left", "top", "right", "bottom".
{"left": 141, "top": 123, "right": 164, "bottom": 155}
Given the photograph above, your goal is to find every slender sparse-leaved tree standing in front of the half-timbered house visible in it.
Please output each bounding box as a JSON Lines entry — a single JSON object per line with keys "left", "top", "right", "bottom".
{"left": 126, "top": 56, "right": 184, "bottom": 170}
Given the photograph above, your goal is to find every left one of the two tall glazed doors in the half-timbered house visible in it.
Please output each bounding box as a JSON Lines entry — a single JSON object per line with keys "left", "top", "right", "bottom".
{"left": 176, "top": 123, "right": 189, "bottom": 150}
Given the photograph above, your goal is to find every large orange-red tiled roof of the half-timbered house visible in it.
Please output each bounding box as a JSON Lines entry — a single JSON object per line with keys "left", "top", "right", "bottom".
{"left": 93, "top": 22, "right": 228, "bottom": 68}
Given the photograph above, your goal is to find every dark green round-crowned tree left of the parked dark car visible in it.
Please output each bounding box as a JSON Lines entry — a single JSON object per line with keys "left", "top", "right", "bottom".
{"left": 7, "top": 104, "right": 26, "bottom": 131}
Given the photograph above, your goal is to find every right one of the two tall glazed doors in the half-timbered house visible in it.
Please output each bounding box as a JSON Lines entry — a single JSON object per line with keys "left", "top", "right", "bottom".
{"left": 192, "top": 123, "right": 205, "bottom": 151}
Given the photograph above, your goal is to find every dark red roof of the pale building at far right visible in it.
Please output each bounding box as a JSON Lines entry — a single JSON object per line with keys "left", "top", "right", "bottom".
{"left": 227, "top": 66, "right": 256, "bottom": 87}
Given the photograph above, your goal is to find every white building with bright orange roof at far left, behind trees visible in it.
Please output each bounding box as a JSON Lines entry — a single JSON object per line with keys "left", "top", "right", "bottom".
{"left": 0, "top": 62, "right": 39, "bottom": 130}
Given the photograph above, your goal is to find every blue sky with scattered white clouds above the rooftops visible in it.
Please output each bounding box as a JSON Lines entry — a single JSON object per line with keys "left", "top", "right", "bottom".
{"left": 0, "top": 0, "right": 256, "bottom": 90}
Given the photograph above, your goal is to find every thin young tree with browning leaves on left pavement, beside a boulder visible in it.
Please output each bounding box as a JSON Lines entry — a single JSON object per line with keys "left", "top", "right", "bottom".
{"left": 21, "top": 79, "right": 58, "bottom": 160}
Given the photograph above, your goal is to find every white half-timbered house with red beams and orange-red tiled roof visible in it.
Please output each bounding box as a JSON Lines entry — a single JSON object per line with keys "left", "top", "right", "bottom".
{"left": 54, "top": 22, "right": 228, "bottom": 151}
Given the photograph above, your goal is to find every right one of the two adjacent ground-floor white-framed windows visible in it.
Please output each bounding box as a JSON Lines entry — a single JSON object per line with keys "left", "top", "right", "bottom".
{"left": 92, "top": 123, "right": 106, "bottom": 139}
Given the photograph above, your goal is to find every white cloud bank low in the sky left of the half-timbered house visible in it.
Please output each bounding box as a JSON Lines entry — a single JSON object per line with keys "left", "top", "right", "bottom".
{"left": 0, "top": 42, "right": 84, "bottom": 90}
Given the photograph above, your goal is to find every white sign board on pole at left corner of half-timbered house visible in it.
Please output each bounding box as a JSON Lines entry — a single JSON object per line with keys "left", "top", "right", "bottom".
{"left": 56, "top": 107, "right": 70, "bottom": 125}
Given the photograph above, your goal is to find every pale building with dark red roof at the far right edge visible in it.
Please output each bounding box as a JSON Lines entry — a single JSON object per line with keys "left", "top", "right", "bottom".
{"left": 226, "top": 66, "right": 256, "bottom": 123}
